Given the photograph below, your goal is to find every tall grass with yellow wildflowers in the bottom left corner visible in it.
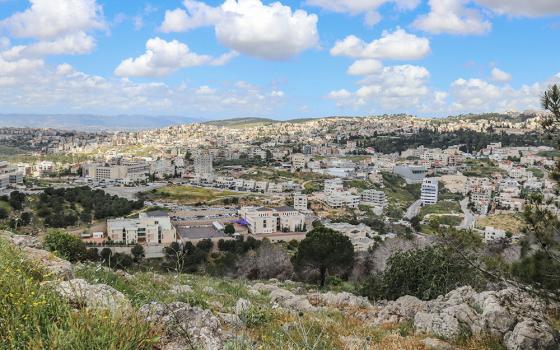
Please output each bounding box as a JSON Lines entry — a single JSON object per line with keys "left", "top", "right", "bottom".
{"left": 0, "top": 240, "right": 159, "bottom": 350}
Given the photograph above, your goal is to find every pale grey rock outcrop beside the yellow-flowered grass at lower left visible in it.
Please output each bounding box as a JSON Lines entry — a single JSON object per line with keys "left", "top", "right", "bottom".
{"left": 53, "top": 278, "right": 131, "bottom": 312}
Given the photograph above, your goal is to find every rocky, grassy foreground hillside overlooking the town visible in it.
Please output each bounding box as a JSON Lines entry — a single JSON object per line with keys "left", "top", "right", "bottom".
{"left": 0, "top": 232, "right": 558, "bottom": 350}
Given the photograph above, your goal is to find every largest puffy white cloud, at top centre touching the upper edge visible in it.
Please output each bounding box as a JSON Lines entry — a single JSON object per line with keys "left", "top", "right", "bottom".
{"left": 161, "top": 0, "right": 319, "bottom": 60}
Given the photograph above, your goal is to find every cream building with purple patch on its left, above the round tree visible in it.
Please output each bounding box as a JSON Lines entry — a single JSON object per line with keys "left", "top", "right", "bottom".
{"left": 239, "top": 206, "right": 305, "bottom": 234}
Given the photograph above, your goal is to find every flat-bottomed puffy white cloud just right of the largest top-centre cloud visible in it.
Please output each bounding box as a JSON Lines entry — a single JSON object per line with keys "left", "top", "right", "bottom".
{"left": 331, "top": 28, "right": 431, "bottom": 60}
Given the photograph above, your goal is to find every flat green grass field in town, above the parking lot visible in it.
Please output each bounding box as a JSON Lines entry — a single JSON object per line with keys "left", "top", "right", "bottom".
{"left": 148, "top": 185, "right": 240, "bottom": 204}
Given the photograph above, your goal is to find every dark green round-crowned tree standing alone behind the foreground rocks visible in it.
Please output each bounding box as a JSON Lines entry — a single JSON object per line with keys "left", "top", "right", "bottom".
{"left": 292, "top": 227, "right": 354, "bottom": 287}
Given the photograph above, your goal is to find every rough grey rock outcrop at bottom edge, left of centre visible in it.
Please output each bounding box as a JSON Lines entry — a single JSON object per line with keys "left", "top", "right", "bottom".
{"left": 140, "top": 302, "right": 225, "bottom": 350}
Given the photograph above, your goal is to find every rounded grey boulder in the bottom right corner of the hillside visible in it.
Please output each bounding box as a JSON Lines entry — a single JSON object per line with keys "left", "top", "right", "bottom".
{"left": 504, "top": 319, "right": 560, "bottom": 350}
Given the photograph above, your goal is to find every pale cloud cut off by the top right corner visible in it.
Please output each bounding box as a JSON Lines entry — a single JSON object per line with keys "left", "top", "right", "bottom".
{"left": 475, "top": 0, "right": 560, "bottom": 17}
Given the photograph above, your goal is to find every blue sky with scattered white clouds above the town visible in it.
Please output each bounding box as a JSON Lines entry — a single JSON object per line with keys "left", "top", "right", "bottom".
{"left": 0, "top": 0, "right": 560, "bottom": 119}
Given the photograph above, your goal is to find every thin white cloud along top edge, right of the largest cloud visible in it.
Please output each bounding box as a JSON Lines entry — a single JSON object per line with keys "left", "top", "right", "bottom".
{"left": 305, "top": 0, "right": 420, "bottom": 26}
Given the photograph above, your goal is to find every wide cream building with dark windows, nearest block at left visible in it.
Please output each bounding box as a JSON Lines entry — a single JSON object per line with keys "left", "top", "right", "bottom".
{"left": 107, "top": 211, "right": 177, "bottom": 245}
